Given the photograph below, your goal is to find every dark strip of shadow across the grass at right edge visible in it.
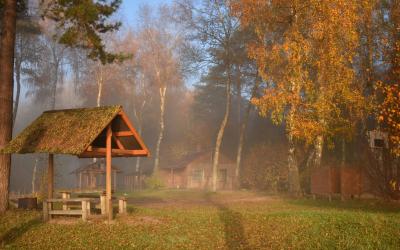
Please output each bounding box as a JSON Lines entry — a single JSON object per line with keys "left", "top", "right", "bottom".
{"left": 285, "top": 199, "right": 400, "bottom": 213}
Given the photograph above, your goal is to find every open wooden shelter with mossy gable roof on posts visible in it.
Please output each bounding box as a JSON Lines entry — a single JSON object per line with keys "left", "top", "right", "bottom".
{"left": 0, "top": 106, "right": 149, "bottom": 218}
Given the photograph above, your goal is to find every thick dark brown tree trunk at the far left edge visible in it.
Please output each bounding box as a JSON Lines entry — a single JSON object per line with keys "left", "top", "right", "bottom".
{"left": 0, "top": 0, "right": 17, "bottom": 214}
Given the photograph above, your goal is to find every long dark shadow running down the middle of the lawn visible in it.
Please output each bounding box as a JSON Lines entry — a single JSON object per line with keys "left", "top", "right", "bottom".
{"left": 205, "top": 193, "right": 252, "bottom": 249}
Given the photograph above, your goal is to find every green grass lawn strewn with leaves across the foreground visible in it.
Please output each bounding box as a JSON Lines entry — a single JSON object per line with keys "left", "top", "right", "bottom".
{"left": 0, "top": 190, "right": 400, "bottom": 249}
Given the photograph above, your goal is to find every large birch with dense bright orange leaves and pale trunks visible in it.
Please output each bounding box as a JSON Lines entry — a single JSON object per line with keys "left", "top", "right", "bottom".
{"left": 233, "top": 0, "right": 365, "bottom": 194}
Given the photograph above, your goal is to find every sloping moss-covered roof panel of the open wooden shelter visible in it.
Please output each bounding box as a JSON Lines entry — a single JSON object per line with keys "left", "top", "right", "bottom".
{"left": 0, "top": 106, "right": 122, "bottom": 155}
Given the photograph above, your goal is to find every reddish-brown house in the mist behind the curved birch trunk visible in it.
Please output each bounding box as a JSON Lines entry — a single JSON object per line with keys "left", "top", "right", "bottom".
{"left": 160, "top": 152, "right": 235, "bottom": 190}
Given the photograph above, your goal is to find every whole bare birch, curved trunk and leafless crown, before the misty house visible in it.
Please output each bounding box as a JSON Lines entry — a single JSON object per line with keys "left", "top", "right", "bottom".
{"left": 177, "top": 0, "right": 239, "bottom": 191}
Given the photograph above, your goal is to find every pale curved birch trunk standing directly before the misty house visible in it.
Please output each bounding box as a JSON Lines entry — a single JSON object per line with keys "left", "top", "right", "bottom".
{"left": 212, "top": 68, "right": 231, "bottom": 192}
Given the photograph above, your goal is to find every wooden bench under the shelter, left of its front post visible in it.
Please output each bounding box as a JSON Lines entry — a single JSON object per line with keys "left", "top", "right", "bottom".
{"left": 43, "top": 198, "right": 91, "bottom": 221}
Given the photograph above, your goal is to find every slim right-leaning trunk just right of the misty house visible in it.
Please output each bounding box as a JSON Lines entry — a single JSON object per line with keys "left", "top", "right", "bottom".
{"left": 235, "top": 78, "right": 260, "bottom": 187}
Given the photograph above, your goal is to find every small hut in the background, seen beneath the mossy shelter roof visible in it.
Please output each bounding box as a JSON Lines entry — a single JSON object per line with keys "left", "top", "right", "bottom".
{"left": 70, "top": 160, "right": 122, "bottom": 190}
